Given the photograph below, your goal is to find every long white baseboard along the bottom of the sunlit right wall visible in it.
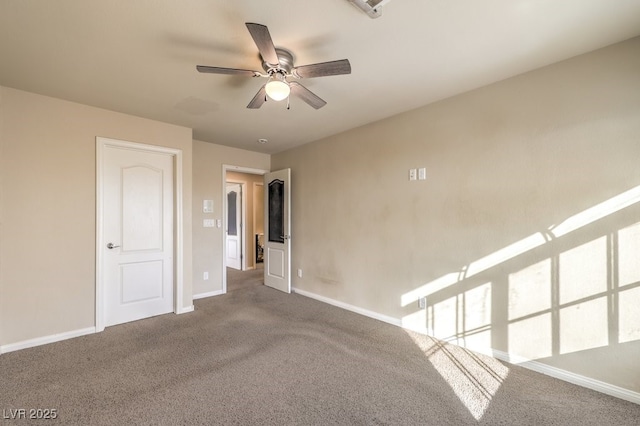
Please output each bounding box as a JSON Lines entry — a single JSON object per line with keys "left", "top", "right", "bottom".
{"left": 293, "top": 288, "right": 640, "bottom": 405}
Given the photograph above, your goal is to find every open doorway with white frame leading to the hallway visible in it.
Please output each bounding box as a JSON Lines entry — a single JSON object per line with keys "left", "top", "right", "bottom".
{"left": 222, "top": 165, "right": 268, "bottom": 293}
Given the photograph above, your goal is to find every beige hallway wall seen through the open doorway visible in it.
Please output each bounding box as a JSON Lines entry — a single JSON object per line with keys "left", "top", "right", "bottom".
{"left": 227, "top": 172, "right": 264, "bottom": 268}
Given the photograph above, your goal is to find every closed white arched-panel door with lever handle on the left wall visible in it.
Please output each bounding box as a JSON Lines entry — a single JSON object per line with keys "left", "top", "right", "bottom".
{"left": 101, "top": 146, "right": 174, "bottom": 326}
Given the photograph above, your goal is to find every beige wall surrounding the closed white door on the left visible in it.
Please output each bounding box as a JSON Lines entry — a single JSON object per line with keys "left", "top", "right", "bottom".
{"left": 0, "top": 87, "right": 192, "bottom": 345}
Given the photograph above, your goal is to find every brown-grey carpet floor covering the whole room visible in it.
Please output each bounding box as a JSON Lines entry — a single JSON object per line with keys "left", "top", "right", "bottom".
{"left": 0, "top": 269, "right": 640, "bottom": 426}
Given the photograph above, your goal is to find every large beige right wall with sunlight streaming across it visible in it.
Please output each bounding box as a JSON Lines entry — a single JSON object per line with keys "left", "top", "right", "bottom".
{"left": 272, "top": 38, "right": 640, "bottom": 392}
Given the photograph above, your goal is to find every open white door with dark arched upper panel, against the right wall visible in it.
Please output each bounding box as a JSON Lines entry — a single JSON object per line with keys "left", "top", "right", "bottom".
{"left": 264, "top": 169, "right": 291, "bottom": 293}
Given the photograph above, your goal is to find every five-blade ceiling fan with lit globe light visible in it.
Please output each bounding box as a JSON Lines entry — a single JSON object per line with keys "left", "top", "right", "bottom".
{"left": 196, "top": 22, "right": 351, "bottom": 109}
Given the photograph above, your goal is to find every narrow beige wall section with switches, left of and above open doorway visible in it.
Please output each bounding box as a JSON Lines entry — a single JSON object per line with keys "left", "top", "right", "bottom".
{"left": 193, "top": 141, "right": 271, "bottom": 296}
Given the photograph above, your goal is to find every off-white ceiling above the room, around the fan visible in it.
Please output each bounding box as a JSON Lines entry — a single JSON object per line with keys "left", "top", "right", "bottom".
{"left": 0, "top": 0, "right": 640, "bottom": 153}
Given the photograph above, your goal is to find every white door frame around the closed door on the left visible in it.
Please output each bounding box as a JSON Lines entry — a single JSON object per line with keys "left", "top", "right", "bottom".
{"left": 96, "top": 136, "right": 186, "bottom": 332}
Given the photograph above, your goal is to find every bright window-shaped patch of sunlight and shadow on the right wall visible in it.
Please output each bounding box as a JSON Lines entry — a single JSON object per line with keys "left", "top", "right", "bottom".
{"left": 401, "top": 186, "right": 640, "bottom": 391}
